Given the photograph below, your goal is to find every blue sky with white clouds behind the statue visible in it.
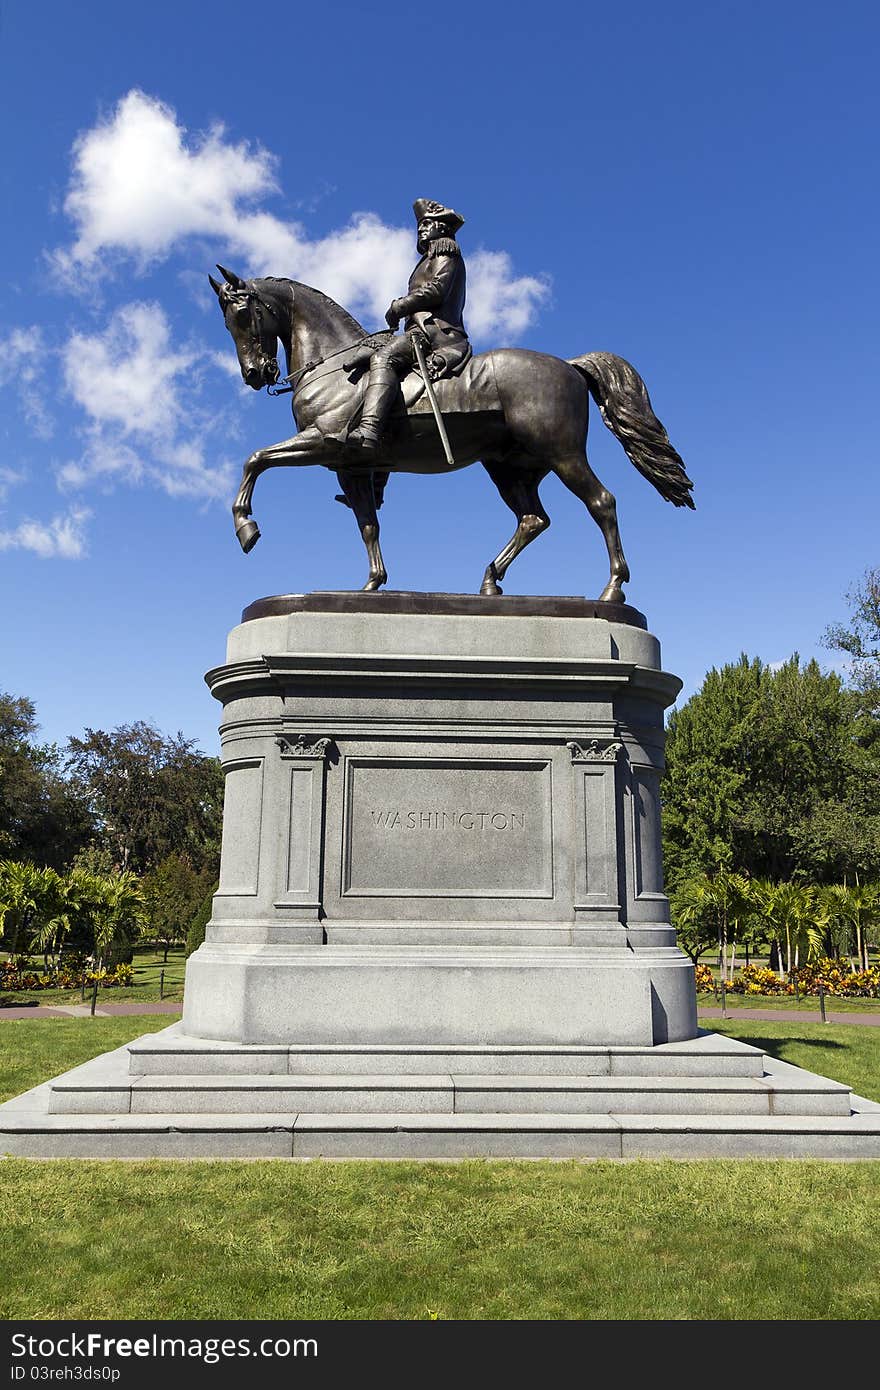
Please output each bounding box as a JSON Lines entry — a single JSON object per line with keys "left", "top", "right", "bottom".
{"left": 0, "top": 0, "right": 880, "bottom": 751}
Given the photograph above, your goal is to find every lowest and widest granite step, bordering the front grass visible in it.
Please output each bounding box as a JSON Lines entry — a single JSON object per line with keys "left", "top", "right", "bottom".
{"left": 0, "top": 1106, "right": 880, "bottom": 1159}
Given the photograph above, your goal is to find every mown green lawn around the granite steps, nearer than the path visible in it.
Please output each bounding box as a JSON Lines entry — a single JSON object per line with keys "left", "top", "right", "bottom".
{"left": 0, "top": 1016, "right": 880, "bottom": 1321}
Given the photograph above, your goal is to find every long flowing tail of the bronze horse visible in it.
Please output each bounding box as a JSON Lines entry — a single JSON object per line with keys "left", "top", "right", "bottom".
{"left": 569, "top": 352, "right": 694, "bottom": 510}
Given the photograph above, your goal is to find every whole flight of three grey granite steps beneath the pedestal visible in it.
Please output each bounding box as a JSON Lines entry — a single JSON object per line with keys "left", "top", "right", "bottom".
{"left": 0, "top": 1023, "right": 880, "bottom": 1159}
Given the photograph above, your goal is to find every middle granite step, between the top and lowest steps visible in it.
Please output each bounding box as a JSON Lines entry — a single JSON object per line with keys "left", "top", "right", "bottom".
{"left": 49, "top": 1063, "right": 849, "bottom": 1116}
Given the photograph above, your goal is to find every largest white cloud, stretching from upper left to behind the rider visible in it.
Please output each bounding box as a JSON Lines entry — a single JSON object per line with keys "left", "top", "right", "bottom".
{"left": 54, "top": 90, "right": 548, "bottom": 339}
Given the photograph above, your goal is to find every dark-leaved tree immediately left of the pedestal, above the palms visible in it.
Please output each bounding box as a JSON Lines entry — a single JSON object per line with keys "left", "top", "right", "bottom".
{"left": 68, "top": 721, "right": 222, "bottom": 874}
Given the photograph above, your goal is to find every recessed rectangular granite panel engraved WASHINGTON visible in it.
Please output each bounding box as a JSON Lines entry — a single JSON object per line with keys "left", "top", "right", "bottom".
{"left": 342, "top": 758, "right": 553, "bottom": 898}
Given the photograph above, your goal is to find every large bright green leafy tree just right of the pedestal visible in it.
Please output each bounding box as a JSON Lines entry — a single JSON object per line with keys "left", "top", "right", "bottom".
{"left": 662, "top": 655, "right": 880, "bottom": 887}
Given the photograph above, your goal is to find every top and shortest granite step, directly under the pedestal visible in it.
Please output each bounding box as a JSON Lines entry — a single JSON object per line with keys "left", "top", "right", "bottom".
{"left": 128, "top": 1024, "right": 765, "bottom": 1076}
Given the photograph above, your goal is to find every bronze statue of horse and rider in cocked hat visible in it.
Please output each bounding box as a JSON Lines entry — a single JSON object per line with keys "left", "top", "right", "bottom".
{"left": 209, "top": 197, "right": 694, "bottom": 603}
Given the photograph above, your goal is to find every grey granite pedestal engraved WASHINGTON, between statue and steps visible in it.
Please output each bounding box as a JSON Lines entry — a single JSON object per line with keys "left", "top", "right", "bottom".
{"left": 184, "top": 594, "right": 696, "bottom": 1045}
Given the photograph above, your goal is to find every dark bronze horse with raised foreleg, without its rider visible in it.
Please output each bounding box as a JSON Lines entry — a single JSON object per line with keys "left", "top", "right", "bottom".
{"left": 209, "top": 265, "right": 694, "bottom": 603}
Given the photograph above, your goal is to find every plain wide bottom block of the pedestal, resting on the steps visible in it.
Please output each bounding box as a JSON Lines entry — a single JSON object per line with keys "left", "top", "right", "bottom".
{"left": 184, "top": 944, "right": 696, "bottom": 1047}
